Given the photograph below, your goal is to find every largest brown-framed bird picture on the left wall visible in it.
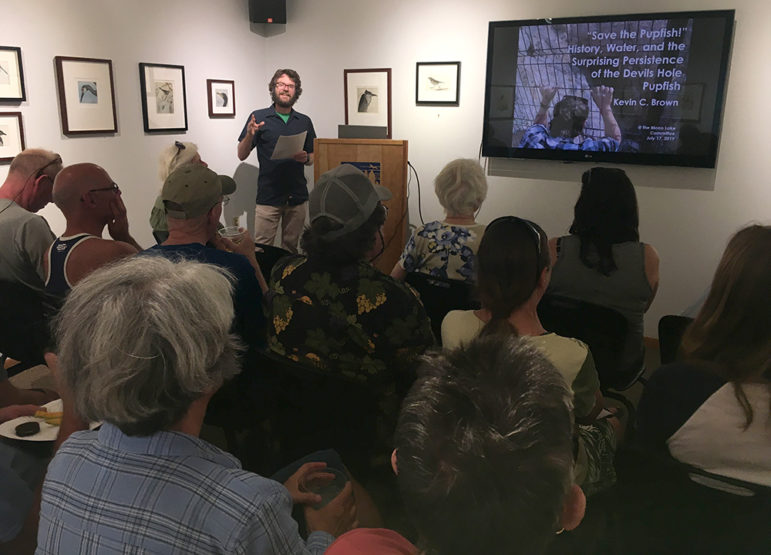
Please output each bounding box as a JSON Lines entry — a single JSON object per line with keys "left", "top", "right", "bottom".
{"left": 54, "top": 56, "right": 118, "bottom": 135}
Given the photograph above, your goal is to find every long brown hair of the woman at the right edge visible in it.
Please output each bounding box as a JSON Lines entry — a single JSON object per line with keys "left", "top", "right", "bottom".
{"left": 682, "top": 225, "right": 771, "bottom": 429}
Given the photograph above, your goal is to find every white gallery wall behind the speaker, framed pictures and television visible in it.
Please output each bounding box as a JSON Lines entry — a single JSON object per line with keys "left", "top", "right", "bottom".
{"left": 0, "top": 0, "right": 771, "bottom": 335}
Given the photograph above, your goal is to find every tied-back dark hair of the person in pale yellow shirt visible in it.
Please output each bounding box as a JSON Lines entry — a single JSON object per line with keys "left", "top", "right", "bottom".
{"left": 476, "top": 216, "right": 550, "bottom": 334}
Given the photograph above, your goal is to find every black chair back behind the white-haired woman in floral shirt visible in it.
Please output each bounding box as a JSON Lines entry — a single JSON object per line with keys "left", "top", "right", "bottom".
{"left": 405, "top": 272, "right": 479, "bottom": 345}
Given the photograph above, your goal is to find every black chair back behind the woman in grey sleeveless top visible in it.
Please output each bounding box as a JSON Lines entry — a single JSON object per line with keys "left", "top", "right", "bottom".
{"left": 538, "top": 295, "right": 644, "bottom": 389}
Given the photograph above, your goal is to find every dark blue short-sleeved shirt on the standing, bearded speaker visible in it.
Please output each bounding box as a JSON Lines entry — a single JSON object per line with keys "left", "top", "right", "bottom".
{"left": 238, "top": 106, "right": 316, "bottom": 206}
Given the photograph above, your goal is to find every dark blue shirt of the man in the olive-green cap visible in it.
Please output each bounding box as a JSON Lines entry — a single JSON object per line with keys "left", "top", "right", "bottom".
{"left": 142, "top": 243, "right": 266, "bottom": 348}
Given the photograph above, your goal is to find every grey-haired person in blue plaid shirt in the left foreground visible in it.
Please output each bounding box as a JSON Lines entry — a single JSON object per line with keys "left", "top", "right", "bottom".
{"left": 37, "top": 258, "right": 355, "bottom": 554}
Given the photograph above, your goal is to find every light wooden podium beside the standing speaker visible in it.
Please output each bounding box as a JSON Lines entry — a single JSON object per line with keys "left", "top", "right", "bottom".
{"left": 313, "top": 139, "right": 407, "bottom": 274}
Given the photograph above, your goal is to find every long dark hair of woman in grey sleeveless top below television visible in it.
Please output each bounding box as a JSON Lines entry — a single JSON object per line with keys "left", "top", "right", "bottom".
{"left": 570, "top": 168, "right": 640, "bottom": 276}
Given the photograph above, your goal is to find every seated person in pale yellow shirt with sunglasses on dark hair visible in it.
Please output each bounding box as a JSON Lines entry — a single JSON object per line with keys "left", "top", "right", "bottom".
{"left": 442, "top": 216, "right": 622, "bottom": 495}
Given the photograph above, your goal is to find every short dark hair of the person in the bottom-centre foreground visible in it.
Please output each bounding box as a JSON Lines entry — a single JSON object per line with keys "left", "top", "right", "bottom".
{"left": 394, "top": 336, "right": 573, "bottom": 555}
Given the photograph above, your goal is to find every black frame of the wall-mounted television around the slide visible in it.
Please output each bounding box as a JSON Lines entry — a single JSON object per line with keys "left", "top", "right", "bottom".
{"left": 482, "top": 10, "right": 735, "bottom": 168}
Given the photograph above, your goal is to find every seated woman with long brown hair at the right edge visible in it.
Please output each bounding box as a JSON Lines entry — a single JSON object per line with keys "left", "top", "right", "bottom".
{"left": 638, "top": 225, "right": 771, "bottom": 487}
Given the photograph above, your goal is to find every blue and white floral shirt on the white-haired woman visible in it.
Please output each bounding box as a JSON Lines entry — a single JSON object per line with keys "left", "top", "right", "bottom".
{"left": 399, "top": 222, "right": 485, "bottom": 283}
